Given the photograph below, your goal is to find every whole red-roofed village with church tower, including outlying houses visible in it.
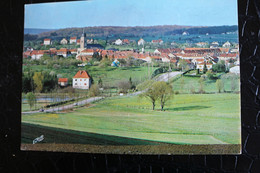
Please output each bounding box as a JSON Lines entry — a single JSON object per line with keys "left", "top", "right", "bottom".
{"left": 23, "top": 30, "right": 239, "bottom": 92}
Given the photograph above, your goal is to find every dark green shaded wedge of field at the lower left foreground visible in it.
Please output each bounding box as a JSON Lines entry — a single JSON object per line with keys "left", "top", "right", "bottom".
{"left": 22, "top": 123, "right": 160, "bottom": 145}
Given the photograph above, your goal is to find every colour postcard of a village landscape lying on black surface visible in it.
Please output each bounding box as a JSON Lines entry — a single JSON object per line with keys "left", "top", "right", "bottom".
{"left": 21, "top": 0, "right": 241, "bottom": 154}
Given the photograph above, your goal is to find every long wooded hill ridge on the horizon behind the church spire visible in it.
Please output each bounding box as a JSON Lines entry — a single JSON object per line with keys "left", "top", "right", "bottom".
{"left": 36, "top": 25, "right": 238, "bottom": 38}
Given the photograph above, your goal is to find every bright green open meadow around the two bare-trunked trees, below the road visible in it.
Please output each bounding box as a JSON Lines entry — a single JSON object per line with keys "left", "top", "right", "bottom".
{"left": 22, "top": 93, "right": 241, "bottom": 144}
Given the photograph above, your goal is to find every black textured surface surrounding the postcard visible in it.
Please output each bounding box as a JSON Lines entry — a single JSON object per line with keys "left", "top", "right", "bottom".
{"left": 0, "top": 0, "right": 260, "bottom": 173}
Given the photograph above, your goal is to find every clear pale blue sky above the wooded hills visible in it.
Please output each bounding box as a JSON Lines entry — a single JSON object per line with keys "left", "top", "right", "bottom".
{"left": 24, "top": 0, "right": 238, "bottom": 29}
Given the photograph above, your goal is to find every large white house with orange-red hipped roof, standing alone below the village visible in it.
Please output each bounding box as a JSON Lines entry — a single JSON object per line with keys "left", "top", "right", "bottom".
{"left": 72, "top": 70, "right": 91, "bottom": 89}
